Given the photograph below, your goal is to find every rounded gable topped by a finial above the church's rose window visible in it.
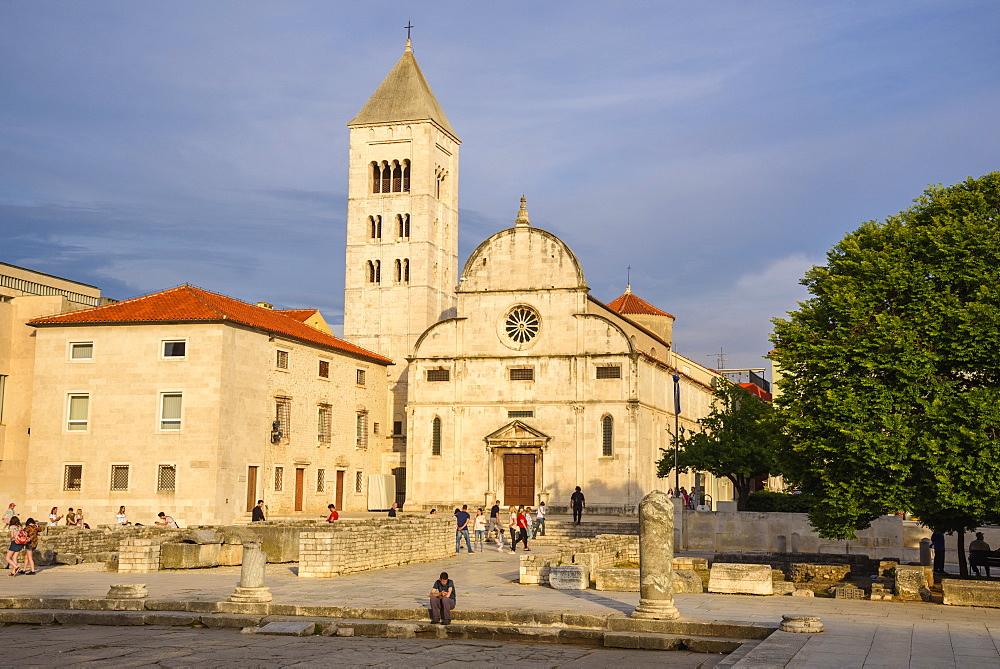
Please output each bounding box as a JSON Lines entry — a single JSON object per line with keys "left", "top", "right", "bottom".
{"left": 458, "top": 197, "right": 587, "bottom": 293}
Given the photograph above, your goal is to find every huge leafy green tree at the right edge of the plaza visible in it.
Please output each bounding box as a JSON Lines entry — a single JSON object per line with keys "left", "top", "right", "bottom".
{"left": 771, "top": 172, "right": 1000, "bottom": 539}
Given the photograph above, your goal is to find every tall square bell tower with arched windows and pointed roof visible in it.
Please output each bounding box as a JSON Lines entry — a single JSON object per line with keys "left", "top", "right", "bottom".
{"left": 344, "top": 39, "right": 461, "bottom": 450}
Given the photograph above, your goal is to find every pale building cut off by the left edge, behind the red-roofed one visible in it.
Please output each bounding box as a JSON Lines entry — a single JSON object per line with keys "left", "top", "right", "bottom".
{"left": 0, "top": 263, "right": 109, "bottom": 498}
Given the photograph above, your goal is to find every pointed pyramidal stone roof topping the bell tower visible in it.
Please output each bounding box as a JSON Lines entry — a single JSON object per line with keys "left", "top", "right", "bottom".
{"left": 347, "top": 40, "right": 458, "bottom": 139}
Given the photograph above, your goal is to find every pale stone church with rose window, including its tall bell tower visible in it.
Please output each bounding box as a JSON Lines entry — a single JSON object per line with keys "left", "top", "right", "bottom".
{"left": 344, "top": 40, "right": 732, "bottom": 512}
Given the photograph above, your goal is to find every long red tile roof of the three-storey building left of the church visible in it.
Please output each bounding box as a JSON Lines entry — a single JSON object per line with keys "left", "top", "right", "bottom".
{"left": 29, "top": 285, "right": 393, "bottom": 365}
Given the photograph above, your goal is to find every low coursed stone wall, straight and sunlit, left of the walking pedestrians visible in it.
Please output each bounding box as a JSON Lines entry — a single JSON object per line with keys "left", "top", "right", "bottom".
{"left": 296, "top": 516, "right": 455, "bottom": 578}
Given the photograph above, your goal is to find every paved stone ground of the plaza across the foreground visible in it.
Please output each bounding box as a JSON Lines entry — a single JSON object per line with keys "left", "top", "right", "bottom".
{"left": 0, "top": 546, "right": 1000, "bottom": 668}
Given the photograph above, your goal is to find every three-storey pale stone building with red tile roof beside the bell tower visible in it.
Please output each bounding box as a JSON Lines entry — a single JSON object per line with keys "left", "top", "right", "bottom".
{"left": 24, "top": 286, "right": 393, "bottom": 524}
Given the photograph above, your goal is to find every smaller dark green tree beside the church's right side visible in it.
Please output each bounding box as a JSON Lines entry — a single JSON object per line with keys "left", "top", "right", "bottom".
{"left": 657, "top": 382, "right": 782, "bottom": 511}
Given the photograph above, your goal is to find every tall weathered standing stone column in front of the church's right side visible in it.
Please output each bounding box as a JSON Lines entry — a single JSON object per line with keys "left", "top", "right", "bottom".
{"left": 632, "top": 490, "right": 680, "bottom": 620}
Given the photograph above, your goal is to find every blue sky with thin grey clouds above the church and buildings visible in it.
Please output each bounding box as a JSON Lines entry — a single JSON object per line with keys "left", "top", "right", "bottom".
{"left": 0, "top": 0, "right": 1000, "bottom": 367}
